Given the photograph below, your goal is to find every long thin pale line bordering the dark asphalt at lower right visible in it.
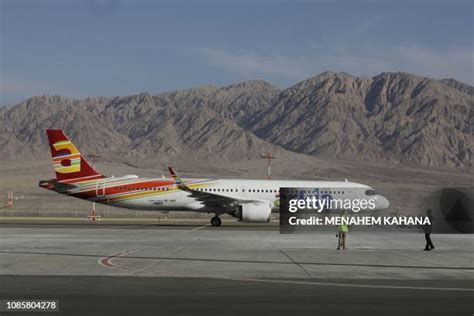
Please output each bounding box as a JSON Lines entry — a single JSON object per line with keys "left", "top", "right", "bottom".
{"left": 224, "top": 278, "right": 474, "bottom": 292}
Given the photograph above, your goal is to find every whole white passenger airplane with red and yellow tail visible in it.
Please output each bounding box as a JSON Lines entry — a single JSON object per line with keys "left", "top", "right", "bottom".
{"left": 39, "top": 129, "right": 389, "bottom": 226}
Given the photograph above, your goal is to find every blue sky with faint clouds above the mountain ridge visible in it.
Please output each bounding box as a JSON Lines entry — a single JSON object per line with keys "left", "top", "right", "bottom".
{"left": 0, "top": 0, "right": 474, "bottom": 105}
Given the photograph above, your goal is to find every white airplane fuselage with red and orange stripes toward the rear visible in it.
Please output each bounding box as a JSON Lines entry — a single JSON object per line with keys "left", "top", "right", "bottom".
{"left": 83, "top": 177, "right": 388, "bottom": 212}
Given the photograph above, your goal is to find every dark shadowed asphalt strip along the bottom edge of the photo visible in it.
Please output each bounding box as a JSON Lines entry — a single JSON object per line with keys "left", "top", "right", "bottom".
{"left": 0, "top": 276, "right": 474, "bottom": 315}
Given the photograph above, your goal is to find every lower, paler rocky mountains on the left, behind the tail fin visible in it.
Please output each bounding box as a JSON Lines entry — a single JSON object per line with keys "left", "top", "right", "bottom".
{"left": 0, "top": 81, "right": 278, "bottom": 160}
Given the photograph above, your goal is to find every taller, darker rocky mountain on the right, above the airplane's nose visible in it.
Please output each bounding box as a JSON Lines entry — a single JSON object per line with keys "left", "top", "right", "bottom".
{"left": 252, "top": 72, "right": 474, "bottom": 166}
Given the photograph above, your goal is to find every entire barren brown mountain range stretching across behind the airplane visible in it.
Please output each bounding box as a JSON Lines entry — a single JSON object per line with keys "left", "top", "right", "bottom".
{"left": 0, "top": 72, "right": 474, "bottom": 168}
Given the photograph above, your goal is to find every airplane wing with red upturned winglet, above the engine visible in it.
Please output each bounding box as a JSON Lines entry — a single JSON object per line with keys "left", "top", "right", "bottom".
{"left": 168, "top": 167, "right": 264, "bottom": 210}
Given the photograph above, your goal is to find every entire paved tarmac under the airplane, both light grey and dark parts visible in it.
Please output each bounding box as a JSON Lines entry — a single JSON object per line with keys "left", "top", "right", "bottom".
{"left": 0, "top": 223, "right": 474, "bottom": 315}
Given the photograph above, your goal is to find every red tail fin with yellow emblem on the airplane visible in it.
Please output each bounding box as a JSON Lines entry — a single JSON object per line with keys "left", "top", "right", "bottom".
{"left": 46, "top": 129, "right": 104, "bottom": 181}
